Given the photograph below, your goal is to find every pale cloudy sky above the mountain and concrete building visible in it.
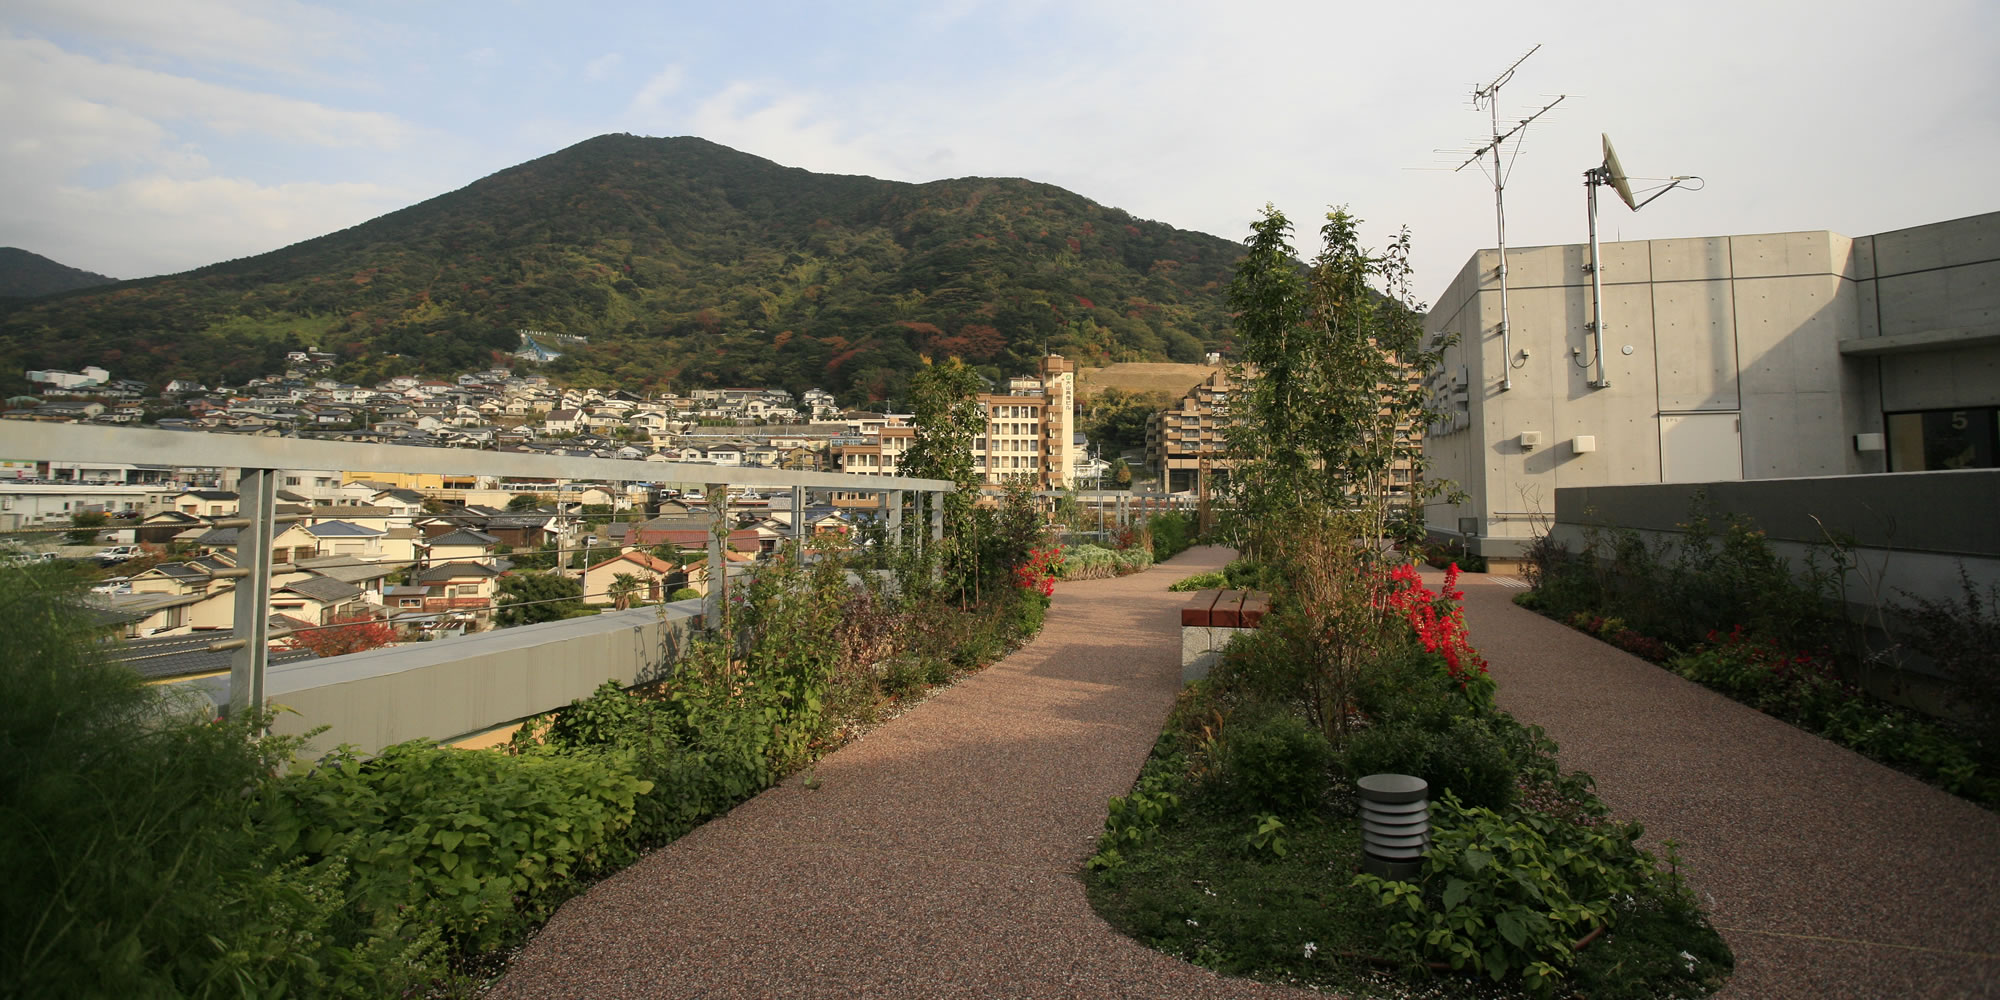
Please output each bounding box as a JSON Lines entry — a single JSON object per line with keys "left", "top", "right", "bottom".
{"left": 0, "top": 0, "right": 2000, "bottom": 300}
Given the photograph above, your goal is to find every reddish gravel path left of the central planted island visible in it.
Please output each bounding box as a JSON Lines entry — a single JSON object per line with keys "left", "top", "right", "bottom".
{"left": 490, "top": 548, "right": 1304, "bottom": 1000}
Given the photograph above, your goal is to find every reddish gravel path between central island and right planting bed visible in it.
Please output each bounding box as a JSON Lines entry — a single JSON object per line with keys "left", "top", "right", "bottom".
{"left": 1464, "top": 576, "right": 2000, "bottom": 1000}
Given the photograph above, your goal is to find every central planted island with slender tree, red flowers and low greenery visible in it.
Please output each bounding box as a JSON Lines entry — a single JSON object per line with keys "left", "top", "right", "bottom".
{"left": 1086, "top": 208, "right": 1734, "bottom": 998}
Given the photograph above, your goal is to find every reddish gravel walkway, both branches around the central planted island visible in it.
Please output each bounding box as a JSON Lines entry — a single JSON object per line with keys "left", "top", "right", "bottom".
{"left": 490, "top": 560, "right": 2000, "bottom": 1000}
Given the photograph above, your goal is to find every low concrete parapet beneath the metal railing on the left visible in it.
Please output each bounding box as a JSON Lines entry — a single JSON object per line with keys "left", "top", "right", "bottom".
{"left": 247, "top": 600, "right": 700, "bottom": 752}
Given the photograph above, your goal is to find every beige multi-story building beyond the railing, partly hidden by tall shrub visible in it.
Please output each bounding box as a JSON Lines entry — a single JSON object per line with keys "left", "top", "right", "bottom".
{"left": 832, "top": 354, "right": 1076, "bottom": 490}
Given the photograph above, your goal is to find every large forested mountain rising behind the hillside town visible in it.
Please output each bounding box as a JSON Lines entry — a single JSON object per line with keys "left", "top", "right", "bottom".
{"left": 0, "top": 134, "right": 1242, "bottom": 402}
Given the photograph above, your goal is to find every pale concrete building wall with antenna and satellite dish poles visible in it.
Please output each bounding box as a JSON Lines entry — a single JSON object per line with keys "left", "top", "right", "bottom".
{"left": 1426, "top": 214, "right": 2000, "bottom": 558}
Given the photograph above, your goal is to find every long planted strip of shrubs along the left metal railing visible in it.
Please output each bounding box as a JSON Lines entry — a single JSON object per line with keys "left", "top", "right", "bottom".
{"left": 0, "top": 470, "right": 1050, "bottom": 998}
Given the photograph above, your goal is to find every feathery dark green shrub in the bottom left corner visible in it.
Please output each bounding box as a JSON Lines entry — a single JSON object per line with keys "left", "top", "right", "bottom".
{"left": 0, "top": 568, "right": 442, "bottom": 996}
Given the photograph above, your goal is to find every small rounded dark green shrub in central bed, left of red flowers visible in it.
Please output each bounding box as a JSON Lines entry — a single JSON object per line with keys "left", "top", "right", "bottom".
{"left": 1214, "top": 706, "right": 1334, "bottom": 816}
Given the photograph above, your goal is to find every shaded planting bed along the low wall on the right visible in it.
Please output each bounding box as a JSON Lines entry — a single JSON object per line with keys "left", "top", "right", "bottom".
{"left": 1516, "top": 500, "right": 2000, "bottom": 808}
